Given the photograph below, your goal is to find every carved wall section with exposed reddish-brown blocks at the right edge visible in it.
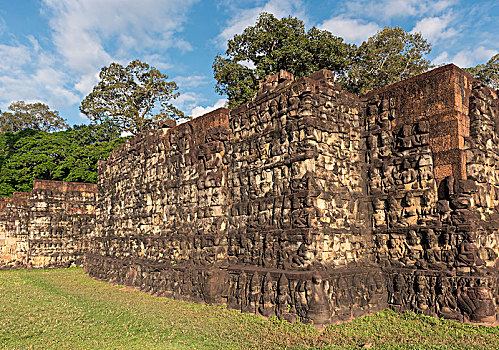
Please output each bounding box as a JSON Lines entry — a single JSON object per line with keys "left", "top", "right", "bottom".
{"left": 364, "top": 65, "right": 497, "bottom": 322}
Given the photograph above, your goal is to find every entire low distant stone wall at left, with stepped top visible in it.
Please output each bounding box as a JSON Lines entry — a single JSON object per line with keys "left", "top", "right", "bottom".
{"left": 0, "top": 180, "right": 97, "bottom": 269}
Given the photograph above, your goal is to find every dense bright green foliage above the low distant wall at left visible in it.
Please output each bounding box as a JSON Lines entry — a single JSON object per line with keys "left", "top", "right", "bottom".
{"left": 0, "top": 123, "right": 126, "bottom": 196}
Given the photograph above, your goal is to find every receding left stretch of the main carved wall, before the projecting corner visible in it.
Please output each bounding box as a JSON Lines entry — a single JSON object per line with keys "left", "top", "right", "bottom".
{"left": 86, "top": 108, "right": 230, "bottom": 300}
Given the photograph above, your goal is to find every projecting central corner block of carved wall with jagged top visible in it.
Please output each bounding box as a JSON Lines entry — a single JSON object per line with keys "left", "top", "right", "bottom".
{"left": 227, "top": 70, "right": 386, "bottom": 324}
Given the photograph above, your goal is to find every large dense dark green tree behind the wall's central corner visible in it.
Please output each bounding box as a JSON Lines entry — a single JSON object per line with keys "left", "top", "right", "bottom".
{"left": 213, "top": 12, "right": 352, "bottom": 108}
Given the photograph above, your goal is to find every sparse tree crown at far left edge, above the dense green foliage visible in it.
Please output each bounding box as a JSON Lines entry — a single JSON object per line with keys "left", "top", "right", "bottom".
{"left": 0, "top": 101, "right": 68, "bottom": 133}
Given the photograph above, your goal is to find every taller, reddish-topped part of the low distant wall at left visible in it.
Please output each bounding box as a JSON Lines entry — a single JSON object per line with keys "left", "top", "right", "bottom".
{"left": 28, "top": 180, "right": 97, "bottom": 268}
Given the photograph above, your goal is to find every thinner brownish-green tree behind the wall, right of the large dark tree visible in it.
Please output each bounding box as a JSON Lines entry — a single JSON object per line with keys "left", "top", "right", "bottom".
{"left": 340, "top": 26, "right": 431, "bottom": 94}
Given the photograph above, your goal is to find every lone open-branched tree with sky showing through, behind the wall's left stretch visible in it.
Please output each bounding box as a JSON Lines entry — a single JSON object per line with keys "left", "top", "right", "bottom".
{"left": 80, "top": 60, "right": 184, "bottom": 135}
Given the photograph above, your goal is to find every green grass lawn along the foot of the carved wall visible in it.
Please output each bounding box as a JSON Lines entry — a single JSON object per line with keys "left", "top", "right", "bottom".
{"left": 0, "top": 268, "right": 499, "bottom": 349}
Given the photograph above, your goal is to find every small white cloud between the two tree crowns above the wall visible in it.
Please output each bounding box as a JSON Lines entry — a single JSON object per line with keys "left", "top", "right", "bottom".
{"left": 318, "top": 16, "right": 381, "bottom": 44}
